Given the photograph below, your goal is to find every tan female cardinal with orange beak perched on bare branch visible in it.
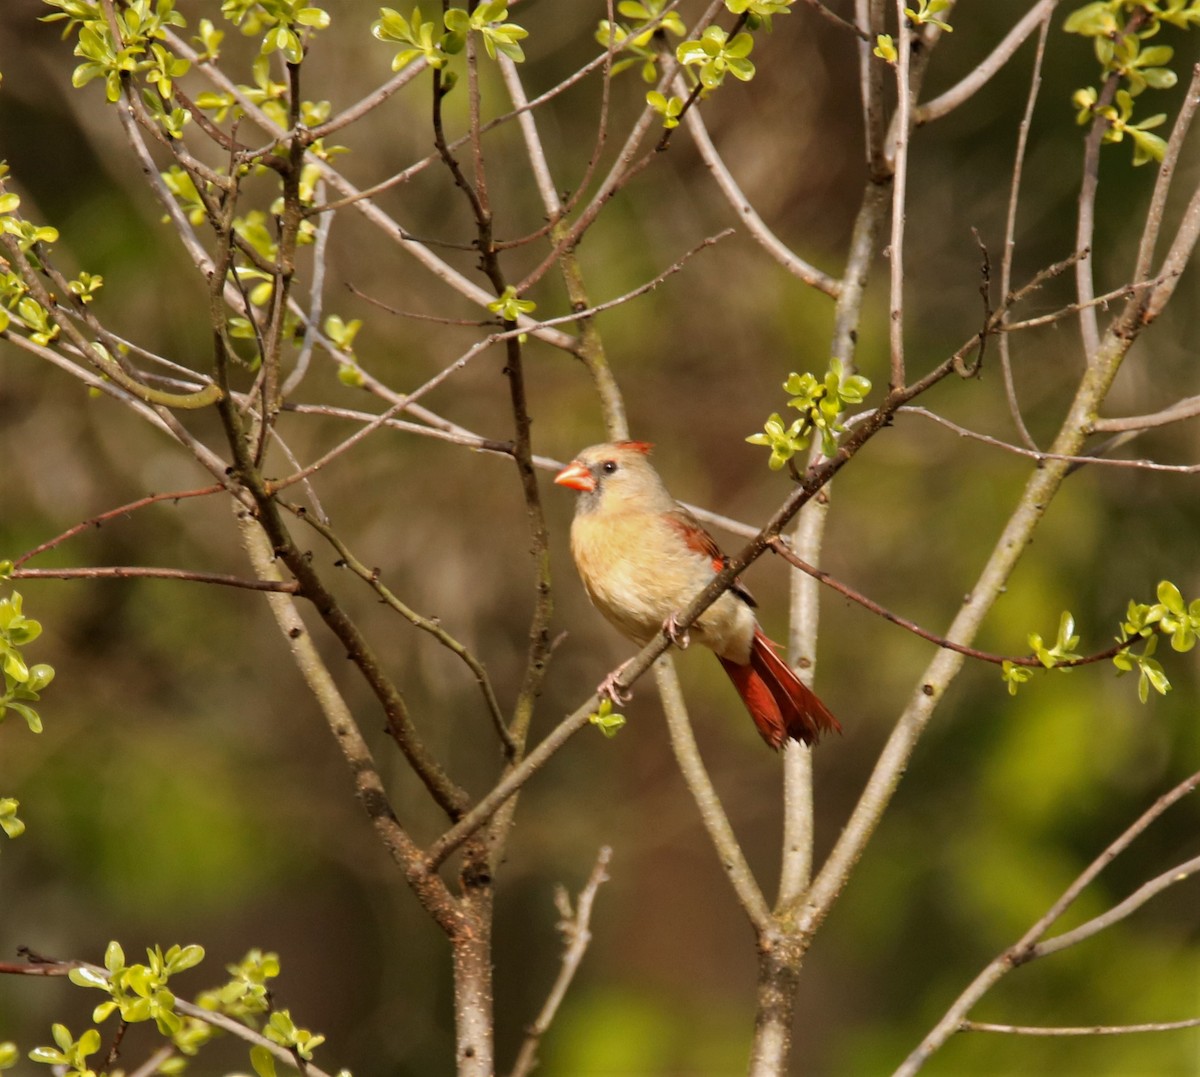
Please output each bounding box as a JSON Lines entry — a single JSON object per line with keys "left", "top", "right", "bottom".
{"left": 554, "top": 441, "right": 841, "bottom": 748}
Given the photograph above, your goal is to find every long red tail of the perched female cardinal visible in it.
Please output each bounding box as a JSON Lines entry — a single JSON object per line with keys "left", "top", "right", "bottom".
{"left": 718, "top": 628, "right": 841, "bottom": 748}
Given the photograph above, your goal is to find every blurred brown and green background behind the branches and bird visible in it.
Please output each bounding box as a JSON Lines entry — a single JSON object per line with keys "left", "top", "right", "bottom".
{"left": 0, "top": 0, "right": 1200, "bottom": 1077}
